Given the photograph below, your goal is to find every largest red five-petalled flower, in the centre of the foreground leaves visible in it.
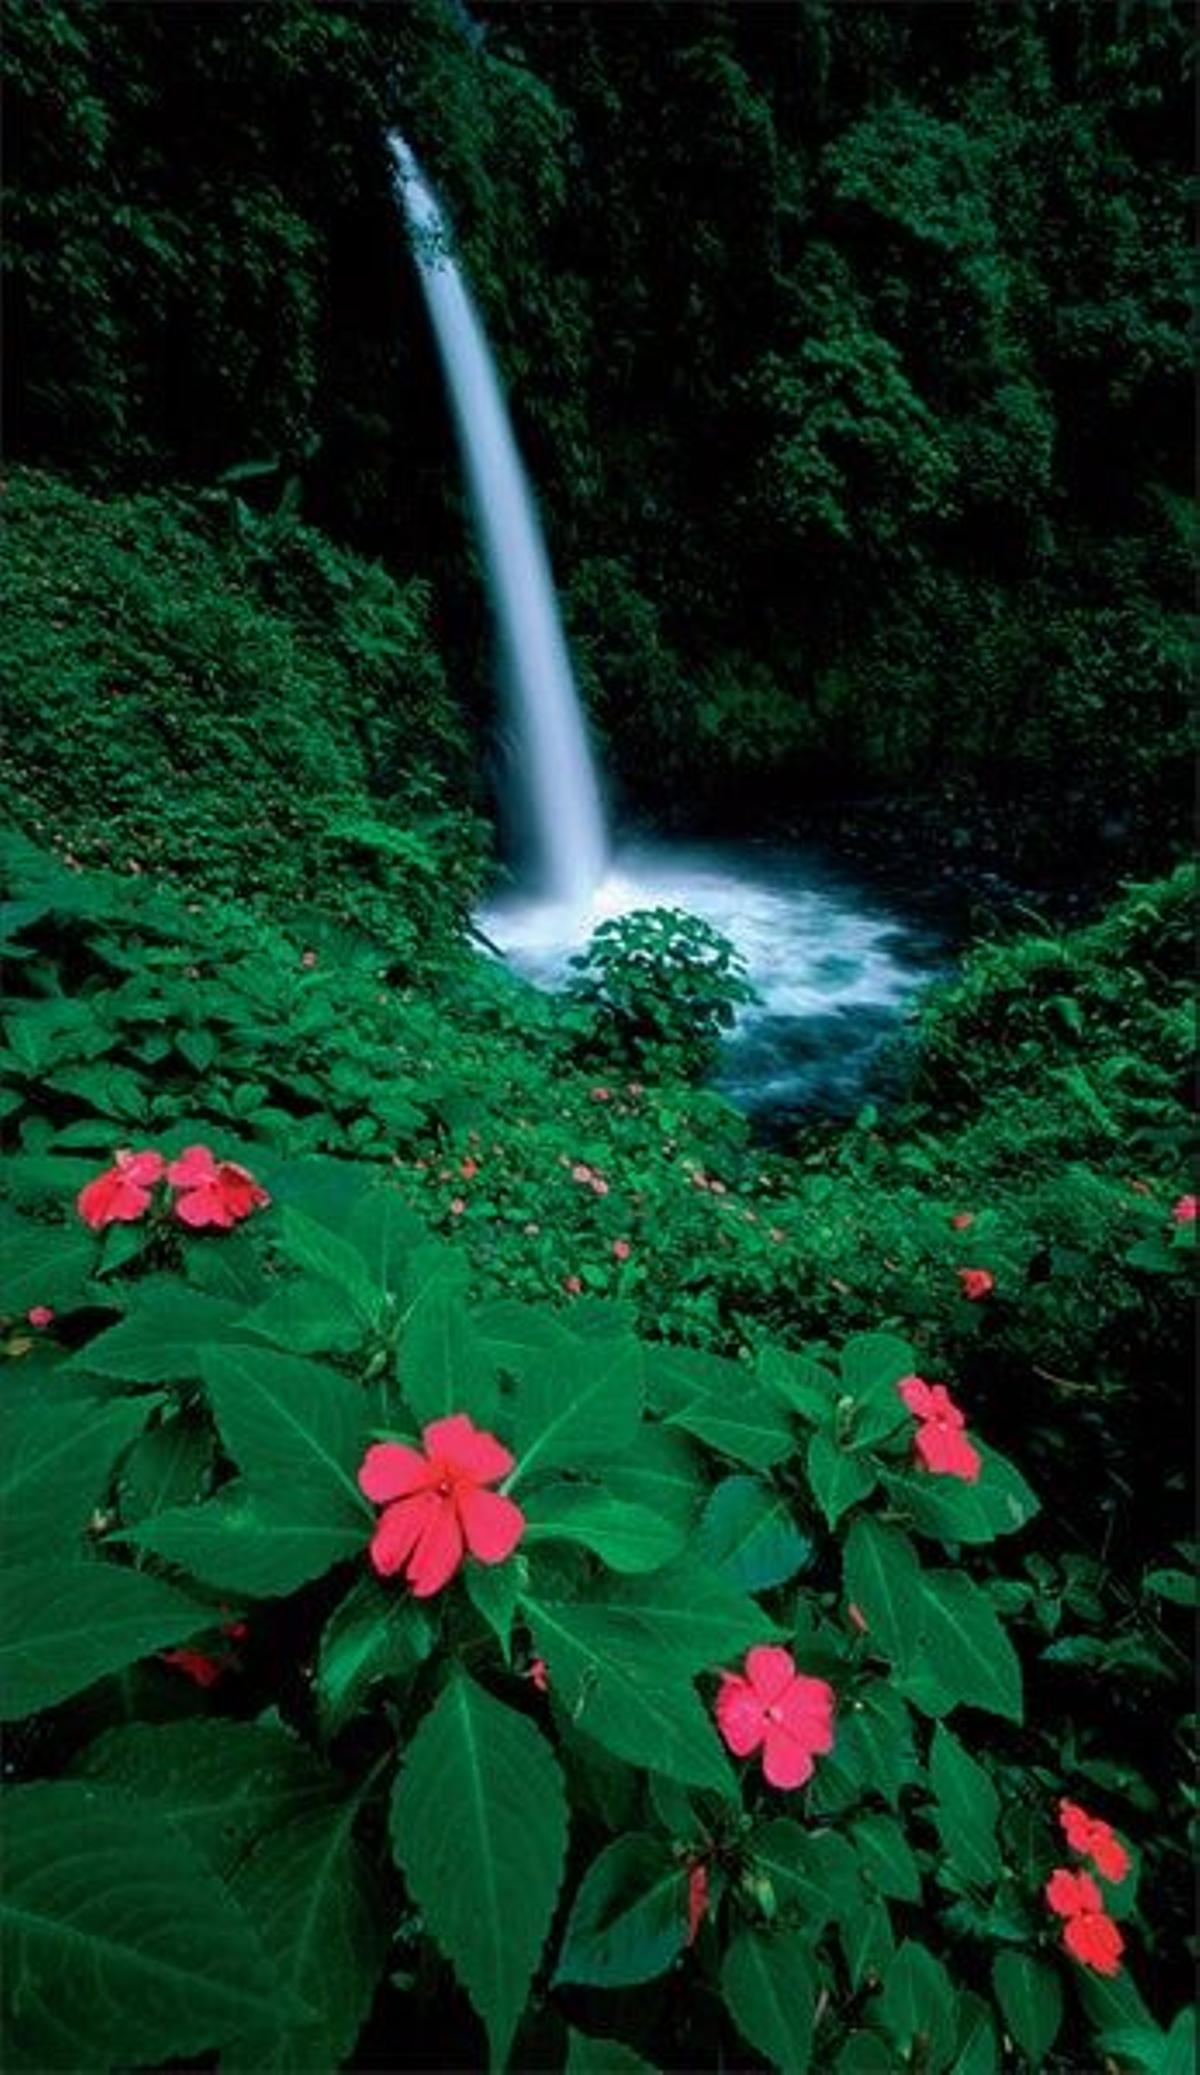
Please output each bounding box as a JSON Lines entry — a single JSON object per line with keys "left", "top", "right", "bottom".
{"left": 359, "top": 1413, "right": 525, "bottom": 1600}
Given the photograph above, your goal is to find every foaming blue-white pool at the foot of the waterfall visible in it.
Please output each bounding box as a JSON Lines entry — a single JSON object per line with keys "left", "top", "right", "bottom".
{"left": 478, "top": 842, "right": 949, "bottom": 1118}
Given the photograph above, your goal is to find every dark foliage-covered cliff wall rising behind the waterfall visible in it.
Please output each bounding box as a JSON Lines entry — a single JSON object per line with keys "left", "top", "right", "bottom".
{"left": 6, "top": 0, "right": 1190, "bottom": 865}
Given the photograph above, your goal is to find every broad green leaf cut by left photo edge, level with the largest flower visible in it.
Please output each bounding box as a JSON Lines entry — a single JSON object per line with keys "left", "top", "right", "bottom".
{"left": 0, "top": 1399, "right": 149, "bottom": 1562}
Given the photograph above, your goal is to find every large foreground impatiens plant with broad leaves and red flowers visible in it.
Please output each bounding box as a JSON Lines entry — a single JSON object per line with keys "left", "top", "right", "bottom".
{"left": 0, "top": 1141, "right": 1179, "bottom": 2075}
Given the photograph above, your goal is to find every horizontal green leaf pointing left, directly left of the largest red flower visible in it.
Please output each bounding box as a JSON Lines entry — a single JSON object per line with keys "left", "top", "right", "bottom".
{"left": 129, "top": 1479, "right": 359, "bottom": 1598}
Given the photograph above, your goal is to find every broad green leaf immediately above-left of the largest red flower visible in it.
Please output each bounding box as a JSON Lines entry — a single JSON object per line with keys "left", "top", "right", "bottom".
{"left": 199, "top": 1347, "right": 374, "bottom": 1521}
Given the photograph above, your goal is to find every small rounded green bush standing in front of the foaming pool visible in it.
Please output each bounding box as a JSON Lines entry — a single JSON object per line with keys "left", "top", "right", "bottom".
{"left": 571, "top": 909, "right": 754, "bottom": 1077}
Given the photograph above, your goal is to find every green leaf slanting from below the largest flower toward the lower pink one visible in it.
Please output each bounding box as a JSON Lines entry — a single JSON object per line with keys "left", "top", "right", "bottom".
{"left": 525, "top": 1596, "right": 731, "bottom": 1793}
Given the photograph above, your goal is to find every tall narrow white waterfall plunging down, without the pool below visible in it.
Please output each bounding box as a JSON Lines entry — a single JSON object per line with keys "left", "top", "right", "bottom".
{"left": 388, "top": 131, "right": 608, "bottom": 907}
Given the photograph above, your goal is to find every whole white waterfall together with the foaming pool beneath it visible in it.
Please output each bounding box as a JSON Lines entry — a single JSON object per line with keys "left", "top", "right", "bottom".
{"left": 388, "top": 131, "right": 940, "bottom": 1116}
